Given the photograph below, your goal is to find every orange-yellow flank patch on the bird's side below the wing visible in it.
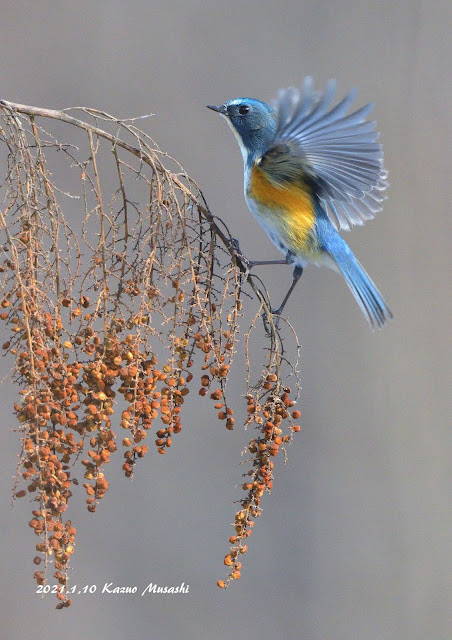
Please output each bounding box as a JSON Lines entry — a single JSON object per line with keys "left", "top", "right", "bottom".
{"left": 248, "top": 164, "right": 315, "bottom": 253}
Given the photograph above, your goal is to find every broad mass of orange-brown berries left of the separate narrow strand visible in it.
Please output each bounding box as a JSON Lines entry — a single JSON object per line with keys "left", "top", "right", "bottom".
{"left": 2, "top": 292, "right": 244, "bottom": 606}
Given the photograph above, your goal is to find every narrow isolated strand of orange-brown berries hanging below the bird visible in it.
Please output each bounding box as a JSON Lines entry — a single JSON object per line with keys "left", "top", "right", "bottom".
{"left": 217, "top": 373, "right": 301, "bottom": 589}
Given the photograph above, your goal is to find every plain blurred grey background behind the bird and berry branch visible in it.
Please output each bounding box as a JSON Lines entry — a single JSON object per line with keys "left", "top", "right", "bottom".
{"left": 0, "top": 0, "right": 452, "bottom": 640}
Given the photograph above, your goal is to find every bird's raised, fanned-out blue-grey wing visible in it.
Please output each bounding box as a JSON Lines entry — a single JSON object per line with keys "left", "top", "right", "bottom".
{"left": 260, "top": 77, "right": 388, "bottom": 229}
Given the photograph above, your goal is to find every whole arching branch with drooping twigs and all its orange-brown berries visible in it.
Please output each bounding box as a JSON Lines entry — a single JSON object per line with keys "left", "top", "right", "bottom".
{"left": 0, "top": 100, "right": 299, "bottom": 608}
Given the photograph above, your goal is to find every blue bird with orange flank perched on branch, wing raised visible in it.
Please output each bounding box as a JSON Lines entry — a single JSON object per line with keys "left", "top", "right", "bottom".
{"left": 208, "top": 77, "right": 392, "bottom": 328}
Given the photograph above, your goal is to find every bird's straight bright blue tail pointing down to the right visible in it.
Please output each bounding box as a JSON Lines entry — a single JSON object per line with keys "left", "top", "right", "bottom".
{"left": 328, "top": 234, "right": 392, "bottom": 329}
